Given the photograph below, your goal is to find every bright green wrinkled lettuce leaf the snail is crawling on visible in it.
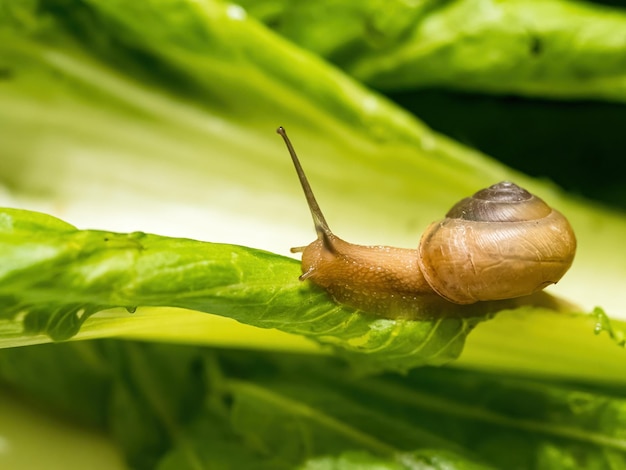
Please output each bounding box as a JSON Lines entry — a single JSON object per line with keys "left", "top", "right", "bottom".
{"left": 0, "top": 209, "right": 623, "bottom": 380}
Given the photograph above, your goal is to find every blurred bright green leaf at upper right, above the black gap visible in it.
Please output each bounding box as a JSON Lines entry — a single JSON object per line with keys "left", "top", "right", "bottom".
{"left": 239, "top": 0, "right": 626, "bottom": 102}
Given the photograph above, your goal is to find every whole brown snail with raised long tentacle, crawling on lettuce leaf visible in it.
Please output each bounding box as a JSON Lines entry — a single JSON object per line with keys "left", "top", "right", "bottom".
{"left": 277, "top": 127, "right": 576, "bottom": 317}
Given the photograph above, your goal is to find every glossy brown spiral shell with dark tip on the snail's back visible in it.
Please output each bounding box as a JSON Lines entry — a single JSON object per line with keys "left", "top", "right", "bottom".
{"left": 418, "top": 181, "right": 576, "bottom": 304}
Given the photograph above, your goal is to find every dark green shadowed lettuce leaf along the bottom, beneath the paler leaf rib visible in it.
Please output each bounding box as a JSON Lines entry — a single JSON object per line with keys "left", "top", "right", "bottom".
{"left": 0, "top": 340, "right": 626, "bottom": 469}
